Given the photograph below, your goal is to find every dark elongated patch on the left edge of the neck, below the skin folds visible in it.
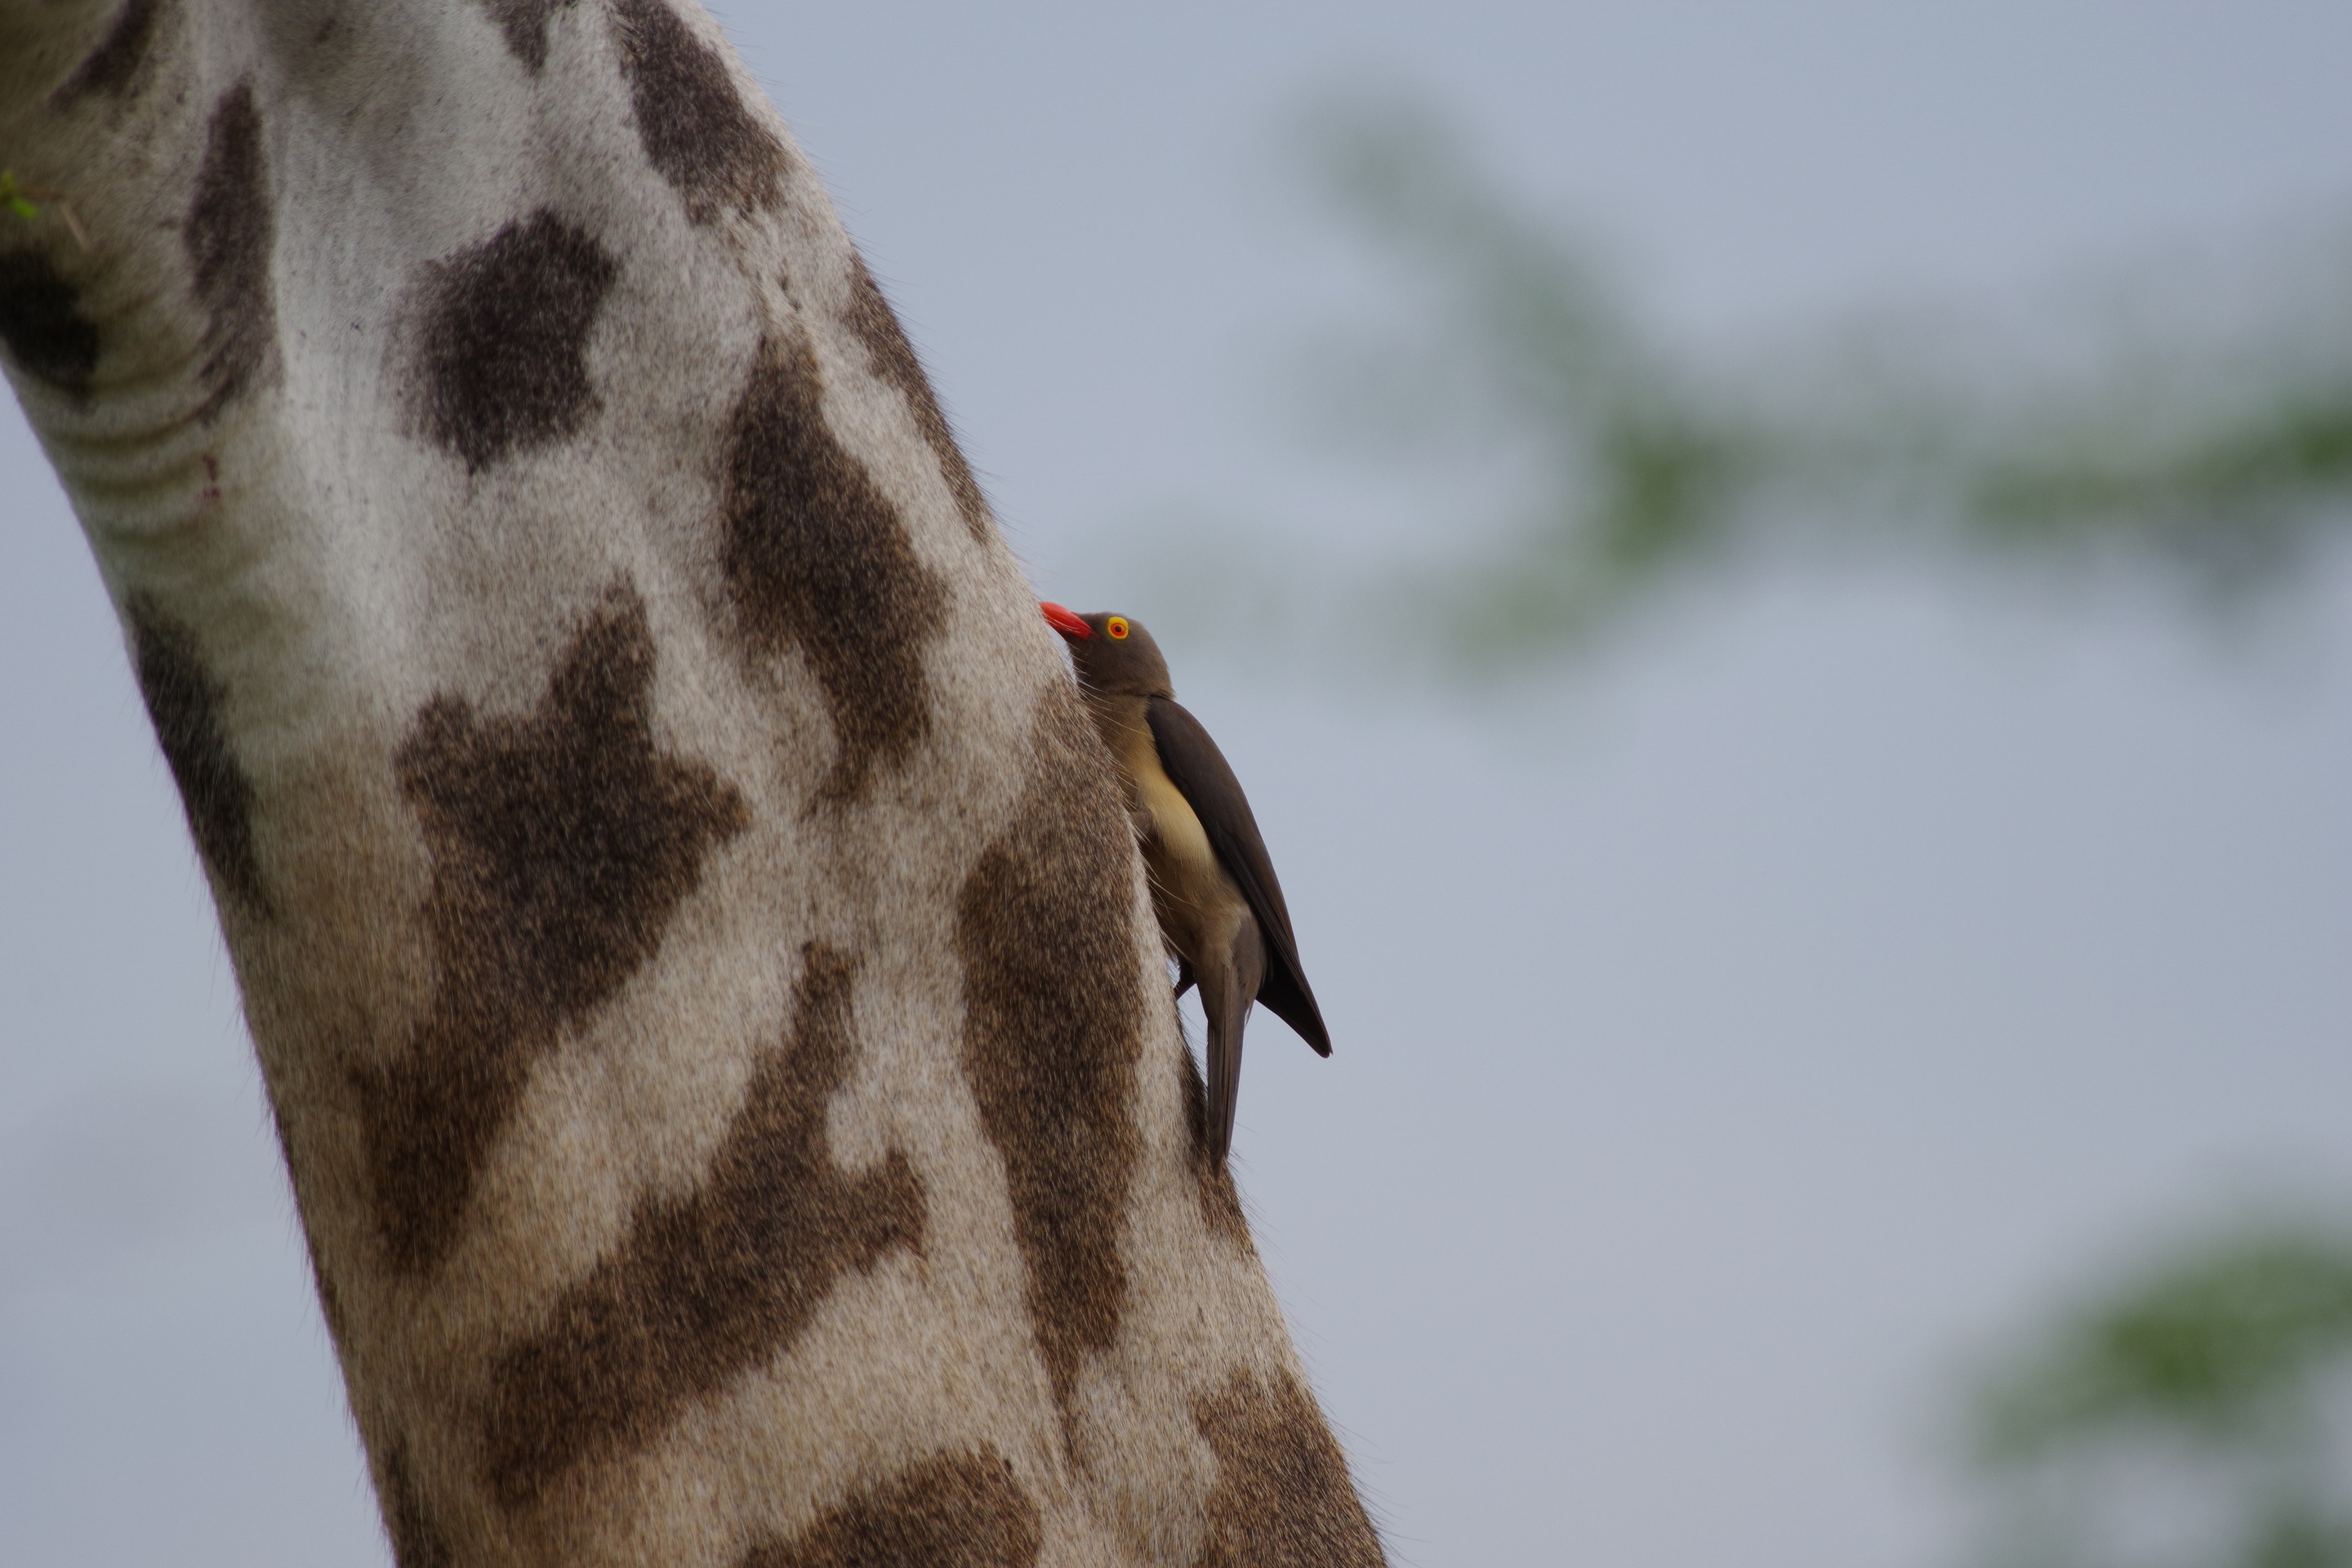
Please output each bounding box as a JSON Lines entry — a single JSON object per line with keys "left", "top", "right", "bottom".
{"left": 122, "top": 592, "right": 270, "bottom": 915}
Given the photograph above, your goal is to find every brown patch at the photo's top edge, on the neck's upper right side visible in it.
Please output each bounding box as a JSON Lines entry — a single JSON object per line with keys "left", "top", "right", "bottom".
{"left": 612, "top": 0, "right": 793, "bottom": 223}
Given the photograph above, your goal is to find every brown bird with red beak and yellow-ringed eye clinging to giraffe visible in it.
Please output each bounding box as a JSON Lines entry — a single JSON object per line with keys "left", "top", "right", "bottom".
{"left": 1040, "top": 602, "right": 1331, "bottom": 1166}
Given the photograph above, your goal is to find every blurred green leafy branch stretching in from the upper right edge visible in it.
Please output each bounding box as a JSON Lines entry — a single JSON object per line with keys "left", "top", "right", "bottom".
{"left": 1296, "top": 94, "right": 2352, "bottom": 675}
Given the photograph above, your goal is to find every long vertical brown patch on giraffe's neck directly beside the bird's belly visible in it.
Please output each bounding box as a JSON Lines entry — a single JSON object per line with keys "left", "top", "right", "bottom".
{"left": 955, "top": 682, "right": 1143, "bottom": 1410}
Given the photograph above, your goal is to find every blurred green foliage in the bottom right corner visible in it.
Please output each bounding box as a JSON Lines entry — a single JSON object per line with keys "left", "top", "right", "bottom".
{"left": 1969, "top": 1220, "right": 2352, "bottom": 1568}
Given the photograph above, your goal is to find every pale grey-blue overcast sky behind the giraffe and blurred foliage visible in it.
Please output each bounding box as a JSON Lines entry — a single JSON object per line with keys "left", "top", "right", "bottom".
{"left": 0, "top": 0, "right": 2352, "bottom": 1568}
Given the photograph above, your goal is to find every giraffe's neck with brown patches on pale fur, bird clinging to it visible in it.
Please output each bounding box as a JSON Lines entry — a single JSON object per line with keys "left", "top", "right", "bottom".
{"left": 0, "top": 0, "right": 1383, "bottom": 1568}
